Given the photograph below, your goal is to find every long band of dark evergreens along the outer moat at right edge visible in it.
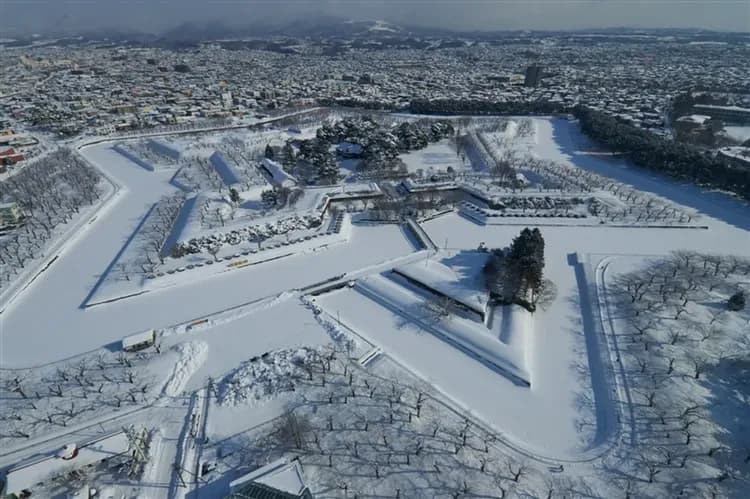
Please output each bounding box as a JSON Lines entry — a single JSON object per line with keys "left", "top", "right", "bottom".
{"left": 574, "top": 107, "right": 750, "bottom": 199}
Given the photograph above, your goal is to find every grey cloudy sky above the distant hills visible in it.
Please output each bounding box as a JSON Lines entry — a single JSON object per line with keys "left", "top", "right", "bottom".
{"left": 0, "top": 0, "right": 750, "bottom": 37}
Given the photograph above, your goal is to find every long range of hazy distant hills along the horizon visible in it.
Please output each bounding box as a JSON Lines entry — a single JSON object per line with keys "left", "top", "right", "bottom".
{"left": 0, "top": 16, "right": 750, "bottom": 49}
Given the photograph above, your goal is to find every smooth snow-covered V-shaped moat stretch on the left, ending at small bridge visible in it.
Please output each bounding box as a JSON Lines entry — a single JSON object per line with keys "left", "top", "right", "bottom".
{"left": 0, "top": 141, "right": 412, "bottom": 367}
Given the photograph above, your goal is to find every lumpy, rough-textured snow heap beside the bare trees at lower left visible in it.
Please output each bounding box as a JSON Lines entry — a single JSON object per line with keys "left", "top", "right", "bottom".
{"left": 218, "top": 347, "right": 318, "bottom": 406}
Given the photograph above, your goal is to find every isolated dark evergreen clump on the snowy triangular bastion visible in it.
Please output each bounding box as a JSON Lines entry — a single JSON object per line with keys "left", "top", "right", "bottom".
{"left": 483, "top": 227, "right": 544, "bottom": 312}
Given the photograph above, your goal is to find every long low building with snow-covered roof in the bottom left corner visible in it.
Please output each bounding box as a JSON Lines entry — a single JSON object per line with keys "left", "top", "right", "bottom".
{"left": 2, "top": 431, "right": 130, "bottom": 496}
